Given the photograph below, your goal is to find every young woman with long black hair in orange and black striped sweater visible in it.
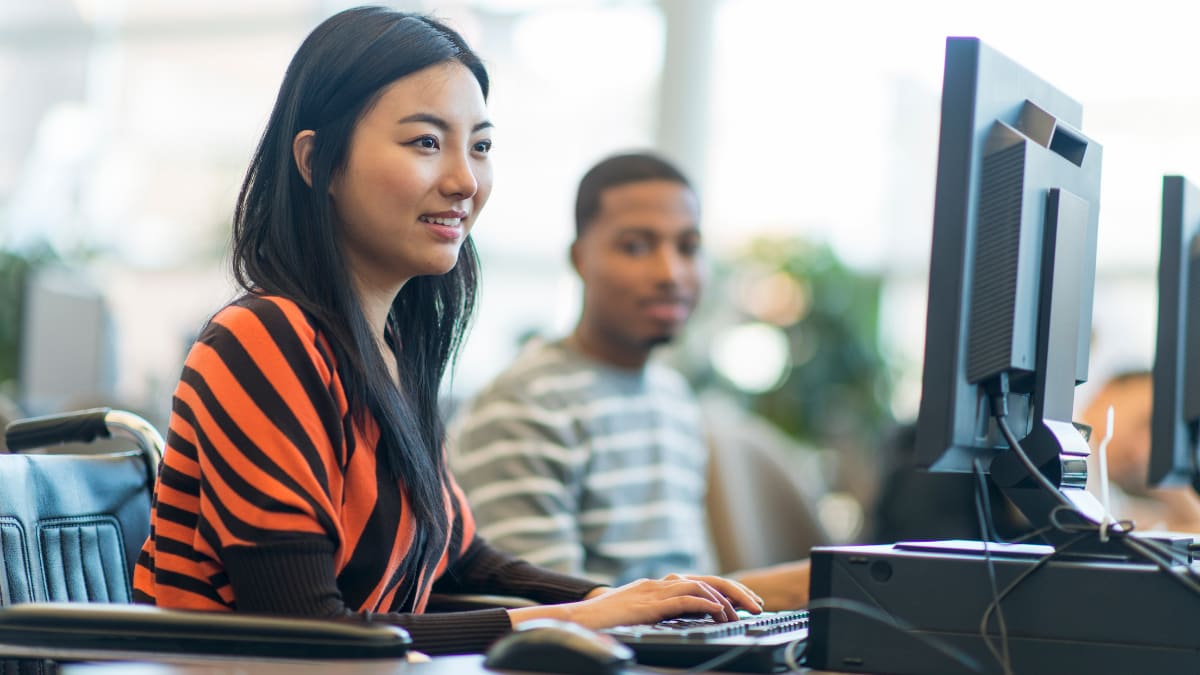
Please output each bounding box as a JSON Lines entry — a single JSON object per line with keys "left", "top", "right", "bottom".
{"left": 134, "top": 7, "right": 761, "bottom": 653}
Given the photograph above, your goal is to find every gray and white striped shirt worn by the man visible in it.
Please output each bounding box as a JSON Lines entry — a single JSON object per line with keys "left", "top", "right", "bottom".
{"left": 446, "top": 341, "right": 712, "bottom": 584}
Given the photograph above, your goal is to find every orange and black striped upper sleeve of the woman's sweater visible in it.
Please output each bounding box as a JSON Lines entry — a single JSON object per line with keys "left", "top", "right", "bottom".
{"left": 174, "top": 298, "right": 342, "bottom": 558}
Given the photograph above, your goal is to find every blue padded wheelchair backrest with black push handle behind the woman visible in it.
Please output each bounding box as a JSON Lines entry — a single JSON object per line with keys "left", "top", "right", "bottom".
{"left": 0, "top": 408, "right": 162, "bottom": 605}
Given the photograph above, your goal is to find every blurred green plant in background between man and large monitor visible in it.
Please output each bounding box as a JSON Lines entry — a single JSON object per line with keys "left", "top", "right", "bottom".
{"left": 683, "top": 235, "right": 893, "bottom": 454}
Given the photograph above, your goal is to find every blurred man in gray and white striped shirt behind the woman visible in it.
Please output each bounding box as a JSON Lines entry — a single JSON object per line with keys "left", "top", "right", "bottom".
{"left": 448, "top": 154, "right": 809, "bottom": 610}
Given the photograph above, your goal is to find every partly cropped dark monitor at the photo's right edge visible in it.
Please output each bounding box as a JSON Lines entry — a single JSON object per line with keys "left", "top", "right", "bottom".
{"left": 1147, "top": 175, "right": 1200, "bottom": 490}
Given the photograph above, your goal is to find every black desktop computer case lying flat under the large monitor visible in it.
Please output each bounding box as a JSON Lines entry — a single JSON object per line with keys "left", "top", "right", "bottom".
{"left": 806, "top": 542, "right": 1200, "bottom": 675}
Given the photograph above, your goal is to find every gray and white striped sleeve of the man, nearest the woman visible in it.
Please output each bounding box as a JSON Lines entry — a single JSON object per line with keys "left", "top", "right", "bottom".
{"left": 448, "top": 388, "right": 586, "bottom": 575}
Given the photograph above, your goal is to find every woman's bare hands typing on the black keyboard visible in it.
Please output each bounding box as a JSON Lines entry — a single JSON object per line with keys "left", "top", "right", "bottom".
{"left": 509, "top": 574, "right": 762, "bottom": 629}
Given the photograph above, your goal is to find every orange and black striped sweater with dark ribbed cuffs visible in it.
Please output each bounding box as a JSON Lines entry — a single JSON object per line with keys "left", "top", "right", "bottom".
{"left": 133, "top": 295, "right": 595, "bottom": 653}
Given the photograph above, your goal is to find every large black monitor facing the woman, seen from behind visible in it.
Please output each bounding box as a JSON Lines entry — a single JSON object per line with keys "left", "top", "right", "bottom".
{"left": 917, "top": 37, "right": 1102, "bottom": 538}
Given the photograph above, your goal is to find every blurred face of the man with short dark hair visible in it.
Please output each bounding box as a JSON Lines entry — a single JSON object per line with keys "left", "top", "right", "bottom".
{"left": 571, "top": 180, "right": 703, "bottom": 363}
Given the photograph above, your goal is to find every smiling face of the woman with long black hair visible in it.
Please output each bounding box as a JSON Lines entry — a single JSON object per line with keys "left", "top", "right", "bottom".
{"left": 330, "top": 61, "right": 492, "bottom": 294}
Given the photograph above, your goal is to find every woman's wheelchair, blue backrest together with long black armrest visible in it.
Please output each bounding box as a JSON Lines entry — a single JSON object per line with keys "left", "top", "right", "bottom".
{"left": 0, "top": 408, "right": 412, "bottom": 658}
